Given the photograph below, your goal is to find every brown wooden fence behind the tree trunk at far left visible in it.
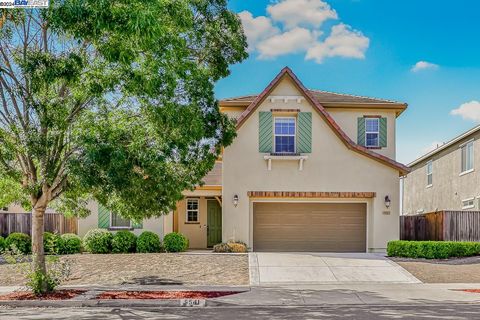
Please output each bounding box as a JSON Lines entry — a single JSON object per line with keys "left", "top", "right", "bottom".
{"left": 0, "top": 212, "right": 78, "bottom": 237}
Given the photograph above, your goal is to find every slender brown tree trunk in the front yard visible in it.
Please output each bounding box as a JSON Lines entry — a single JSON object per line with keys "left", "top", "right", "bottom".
{"left": 32, "top": 202, "right": 48, "bottom": 293}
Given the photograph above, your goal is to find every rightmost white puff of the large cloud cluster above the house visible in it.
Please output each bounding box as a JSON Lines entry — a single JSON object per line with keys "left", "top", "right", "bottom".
{"left": 305, "top": 23, "right": 370, "bottom": 63}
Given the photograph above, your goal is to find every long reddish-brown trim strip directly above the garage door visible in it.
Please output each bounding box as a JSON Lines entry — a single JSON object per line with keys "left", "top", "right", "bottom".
{"left": 247, "top": 191, "right": 376, "bottom": 199}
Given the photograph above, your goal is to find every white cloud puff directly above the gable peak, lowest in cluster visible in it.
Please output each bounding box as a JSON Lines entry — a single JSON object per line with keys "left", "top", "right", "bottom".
{"left": 258, "top": 28, "right": 317, "bottom": 59}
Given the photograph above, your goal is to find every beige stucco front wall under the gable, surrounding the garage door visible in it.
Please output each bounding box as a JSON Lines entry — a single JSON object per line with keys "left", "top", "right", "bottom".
{"left": 223, "top": 75, "right": 400, "bottom": 251}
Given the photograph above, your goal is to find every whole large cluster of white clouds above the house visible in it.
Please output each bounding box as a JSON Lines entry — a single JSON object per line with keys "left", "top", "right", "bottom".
{"left": 239, "top": 0, "right": 370, "bottom": 63}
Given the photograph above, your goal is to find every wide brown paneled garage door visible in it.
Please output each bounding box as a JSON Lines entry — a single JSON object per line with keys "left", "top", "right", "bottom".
{"left": 253, "top": 202, "right": 366, "bottom": 252}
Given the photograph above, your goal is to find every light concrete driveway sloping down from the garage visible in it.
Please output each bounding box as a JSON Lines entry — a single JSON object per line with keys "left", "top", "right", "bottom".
{"left": 249, "top": 252, "right": 420, "bottom": 286}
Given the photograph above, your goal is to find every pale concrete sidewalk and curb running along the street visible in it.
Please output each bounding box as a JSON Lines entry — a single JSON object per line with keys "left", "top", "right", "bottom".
{"left": 0, "top": 283, "right": 480, "bottom": 307}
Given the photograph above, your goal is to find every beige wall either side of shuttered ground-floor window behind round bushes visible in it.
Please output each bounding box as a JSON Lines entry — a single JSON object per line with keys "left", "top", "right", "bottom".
{"left": 78, "top": 201, "right": 164, "bottom": 239}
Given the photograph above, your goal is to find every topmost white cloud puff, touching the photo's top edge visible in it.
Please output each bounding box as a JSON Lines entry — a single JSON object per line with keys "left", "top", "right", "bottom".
{"left": 267, "top": 0, "right": 338, "bottom": 29}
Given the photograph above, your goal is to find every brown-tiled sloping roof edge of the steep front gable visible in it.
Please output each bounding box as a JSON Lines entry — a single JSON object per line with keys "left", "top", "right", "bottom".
{"left": 232, "top": 67, "right": 410, "bottom": 175}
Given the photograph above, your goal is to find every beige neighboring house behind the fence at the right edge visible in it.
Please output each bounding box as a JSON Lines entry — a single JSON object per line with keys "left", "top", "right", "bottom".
{"left": 403, "top": 126, "right": 480, "bottom": 214}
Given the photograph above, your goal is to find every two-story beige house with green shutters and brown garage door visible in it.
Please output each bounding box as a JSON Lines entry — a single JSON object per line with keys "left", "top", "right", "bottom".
{"left": 164, "top": 68, "right": 408, "bottom": 252}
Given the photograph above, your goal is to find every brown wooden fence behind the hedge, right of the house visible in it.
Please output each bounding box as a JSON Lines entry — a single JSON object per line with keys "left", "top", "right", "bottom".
{"left": 400, "top": 211, "right": 480, "bottom": 241}
